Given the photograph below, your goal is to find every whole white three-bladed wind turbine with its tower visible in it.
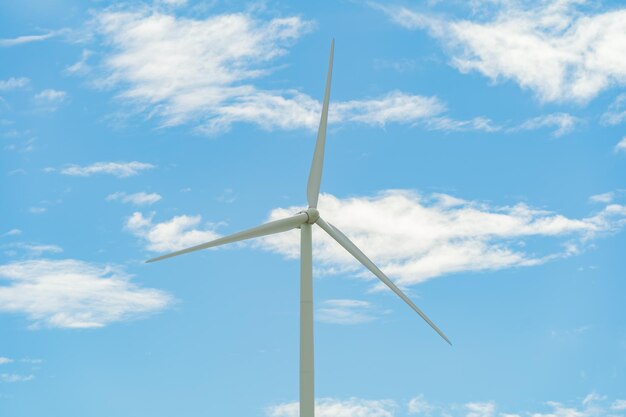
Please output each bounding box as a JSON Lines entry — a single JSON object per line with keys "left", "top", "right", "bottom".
{"left": 146, "top": 40, "right": 452, "bottom": 417}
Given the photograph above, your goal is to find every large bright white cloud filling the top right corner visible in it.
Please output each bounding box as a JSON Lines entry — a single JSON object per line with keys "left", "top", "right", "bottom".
{"left": 378, "top": 0, "right": 626, "bottom": 102}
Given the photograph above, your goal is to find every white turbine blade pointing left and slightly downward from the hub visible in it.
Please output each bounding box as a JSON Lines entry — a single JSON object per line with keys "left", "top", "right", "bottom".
{"left": 146, "top": 213, "right": 309, "bottom": 263}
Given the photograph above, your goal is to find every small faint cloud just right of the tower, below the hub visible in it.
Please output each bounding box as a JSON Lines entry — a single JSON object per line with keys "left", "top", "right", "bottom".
{"left": 315, "top": 299, "right": 380, "bottom": 324}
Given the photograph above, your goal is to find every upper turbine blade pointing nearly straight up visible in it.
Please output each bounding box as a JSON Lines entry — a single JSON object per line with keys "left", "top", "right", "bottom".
{"left": 306, "top": 39, "right": 335, "bottom": 208}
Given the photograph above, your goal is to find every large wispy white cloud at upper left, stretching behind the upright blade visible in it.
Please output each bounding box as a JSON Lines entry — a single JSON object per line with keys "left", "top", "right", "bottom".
{"left": 85, "top": 9, "right": 478, "bottom": 134}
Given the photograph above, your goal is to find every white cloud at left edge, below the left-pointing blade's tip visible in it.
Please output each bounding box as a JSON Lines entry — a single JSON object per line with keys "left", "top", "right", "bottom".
{"left": 0, "top": 259, "right": 172, "bottom": 328}
